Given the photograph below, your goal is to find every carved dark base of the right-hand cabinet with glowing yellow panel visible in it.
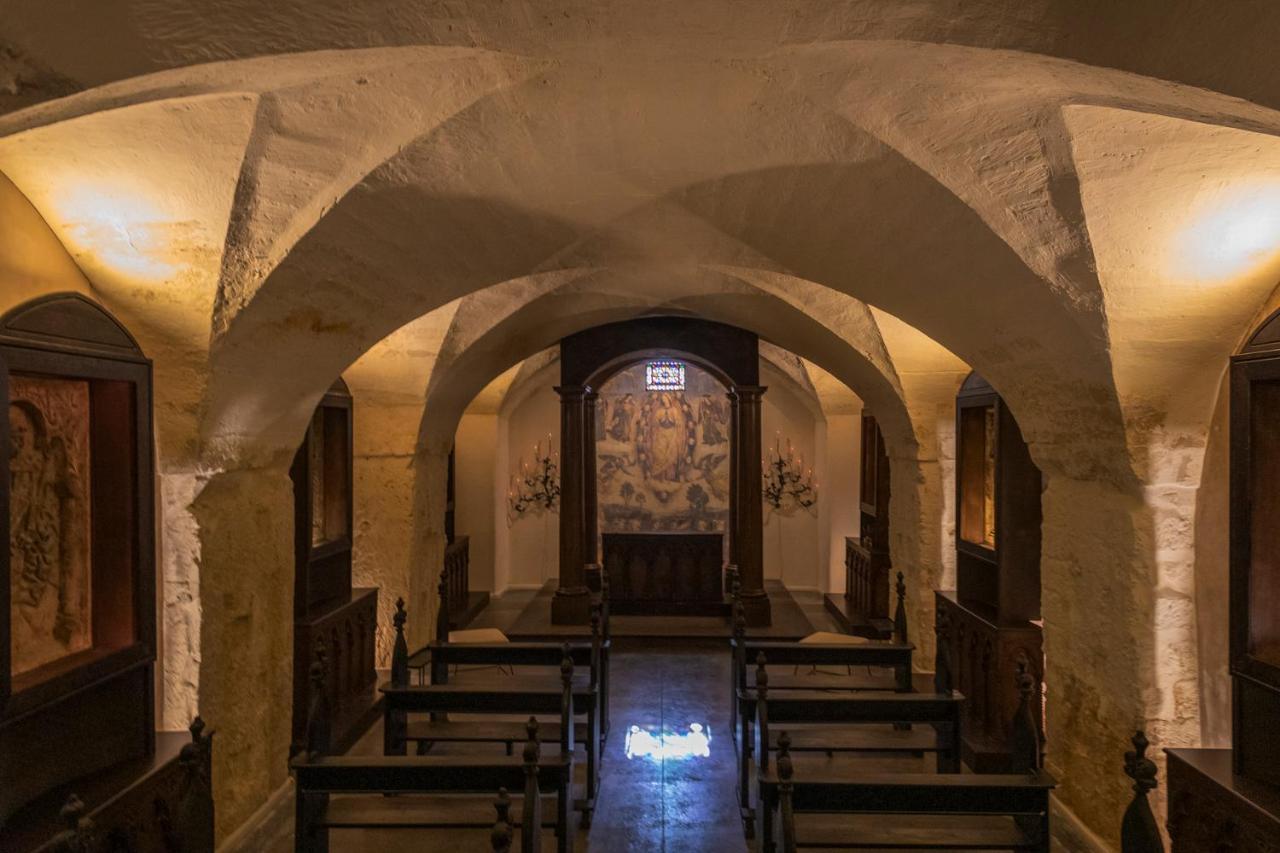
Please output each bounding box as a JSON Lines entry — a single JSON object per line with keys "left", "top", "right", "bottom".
{"left": 934, "top": 592, "right": 1044, "bottom": 772}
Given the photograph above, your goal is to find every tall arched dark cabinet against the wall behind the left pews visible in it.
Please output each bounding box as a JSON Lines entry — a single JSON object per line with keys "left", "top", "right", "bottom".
{"left": 289, "top": 379, "right": 378, "bottom": 748}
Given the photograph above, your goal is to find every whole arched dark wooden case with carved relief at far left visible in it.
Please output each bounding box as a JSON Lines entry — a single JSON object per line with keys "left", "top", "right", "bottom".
{"left": 0, "top": 293, "right": 155, "bottom": 820}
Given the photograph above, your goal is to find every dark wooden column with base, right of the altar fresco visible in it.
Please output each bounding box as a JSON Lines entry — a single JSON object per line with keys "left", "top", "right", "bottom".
{"left": 733, "top": 386, "right": 772, "bottom": 626}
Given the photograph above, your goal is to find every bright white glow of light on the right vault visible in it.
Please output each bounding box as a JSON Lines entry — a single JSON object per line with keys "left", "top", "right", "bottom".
{"left": 1178, "top": 182, "right": 1280, "bottom": 280}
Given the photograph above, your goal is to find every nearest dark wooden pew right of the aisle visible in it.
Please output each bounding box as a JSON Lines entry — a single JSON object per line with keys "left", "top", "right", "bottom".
{"left": 758, "top": 672, "right": 1056, "bottom": 853}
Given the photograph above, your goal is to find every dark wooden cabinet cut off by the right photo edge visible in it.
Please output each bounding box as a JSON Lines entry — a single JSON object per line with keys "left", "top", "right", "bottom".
{"left": 1167, "top": 308, "right": 1280, "bottom": 853}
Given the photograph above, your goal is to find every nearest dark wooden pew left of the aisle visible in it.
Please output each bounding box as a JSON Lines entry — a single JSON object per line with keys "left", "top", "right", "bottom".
{"left": 291, "top": 653, "right": 573, "bottom": 853}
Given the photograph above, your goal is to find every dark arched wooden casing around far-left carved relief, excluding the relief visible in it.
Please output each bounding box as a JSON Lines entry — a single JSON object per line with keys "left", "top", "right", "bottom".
{"left": 0, "top": 293, "right": 156, "bottom": 819}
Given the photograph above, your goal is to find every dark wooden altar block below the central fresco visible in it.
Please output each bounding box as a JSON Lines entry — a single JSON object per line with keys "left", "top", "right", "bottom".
{"left": 603, "top": 533, "right": 724, "bottom": 616}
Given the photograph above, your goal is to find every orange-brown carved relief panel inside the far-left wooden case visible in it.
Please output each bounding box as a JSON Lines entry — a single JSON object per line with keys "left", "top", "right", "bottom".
{"left": 9, "top": 375, "right": 93, "bottom": 675}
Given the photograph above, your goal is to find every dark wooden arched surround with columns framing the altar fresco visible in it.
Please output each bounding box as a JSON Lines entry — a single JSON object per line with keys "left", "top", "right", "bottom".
{"left": 552, "top": 316, "right": 771, "bottom": 625}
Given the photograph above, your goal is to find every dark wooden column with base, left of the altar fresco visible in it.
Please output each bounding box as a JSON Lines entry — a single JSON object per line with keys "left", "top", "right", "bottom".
{"left": 552, "top": 386, "right": 591, "bottom": 625}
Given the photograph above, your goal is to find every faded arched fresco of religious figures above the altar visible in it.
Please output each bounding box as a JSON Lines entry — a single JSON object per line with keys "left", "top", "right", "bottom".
{"left": 595, "top": 362, "right": 730, "bottom": 533}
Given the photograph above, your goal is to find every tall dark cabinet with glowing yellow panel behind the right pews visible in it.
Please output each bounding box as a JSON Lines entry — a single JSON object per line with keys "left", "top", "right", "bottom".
{"left": 936, "top": 373, "right": 1044, "bottom": 772}
